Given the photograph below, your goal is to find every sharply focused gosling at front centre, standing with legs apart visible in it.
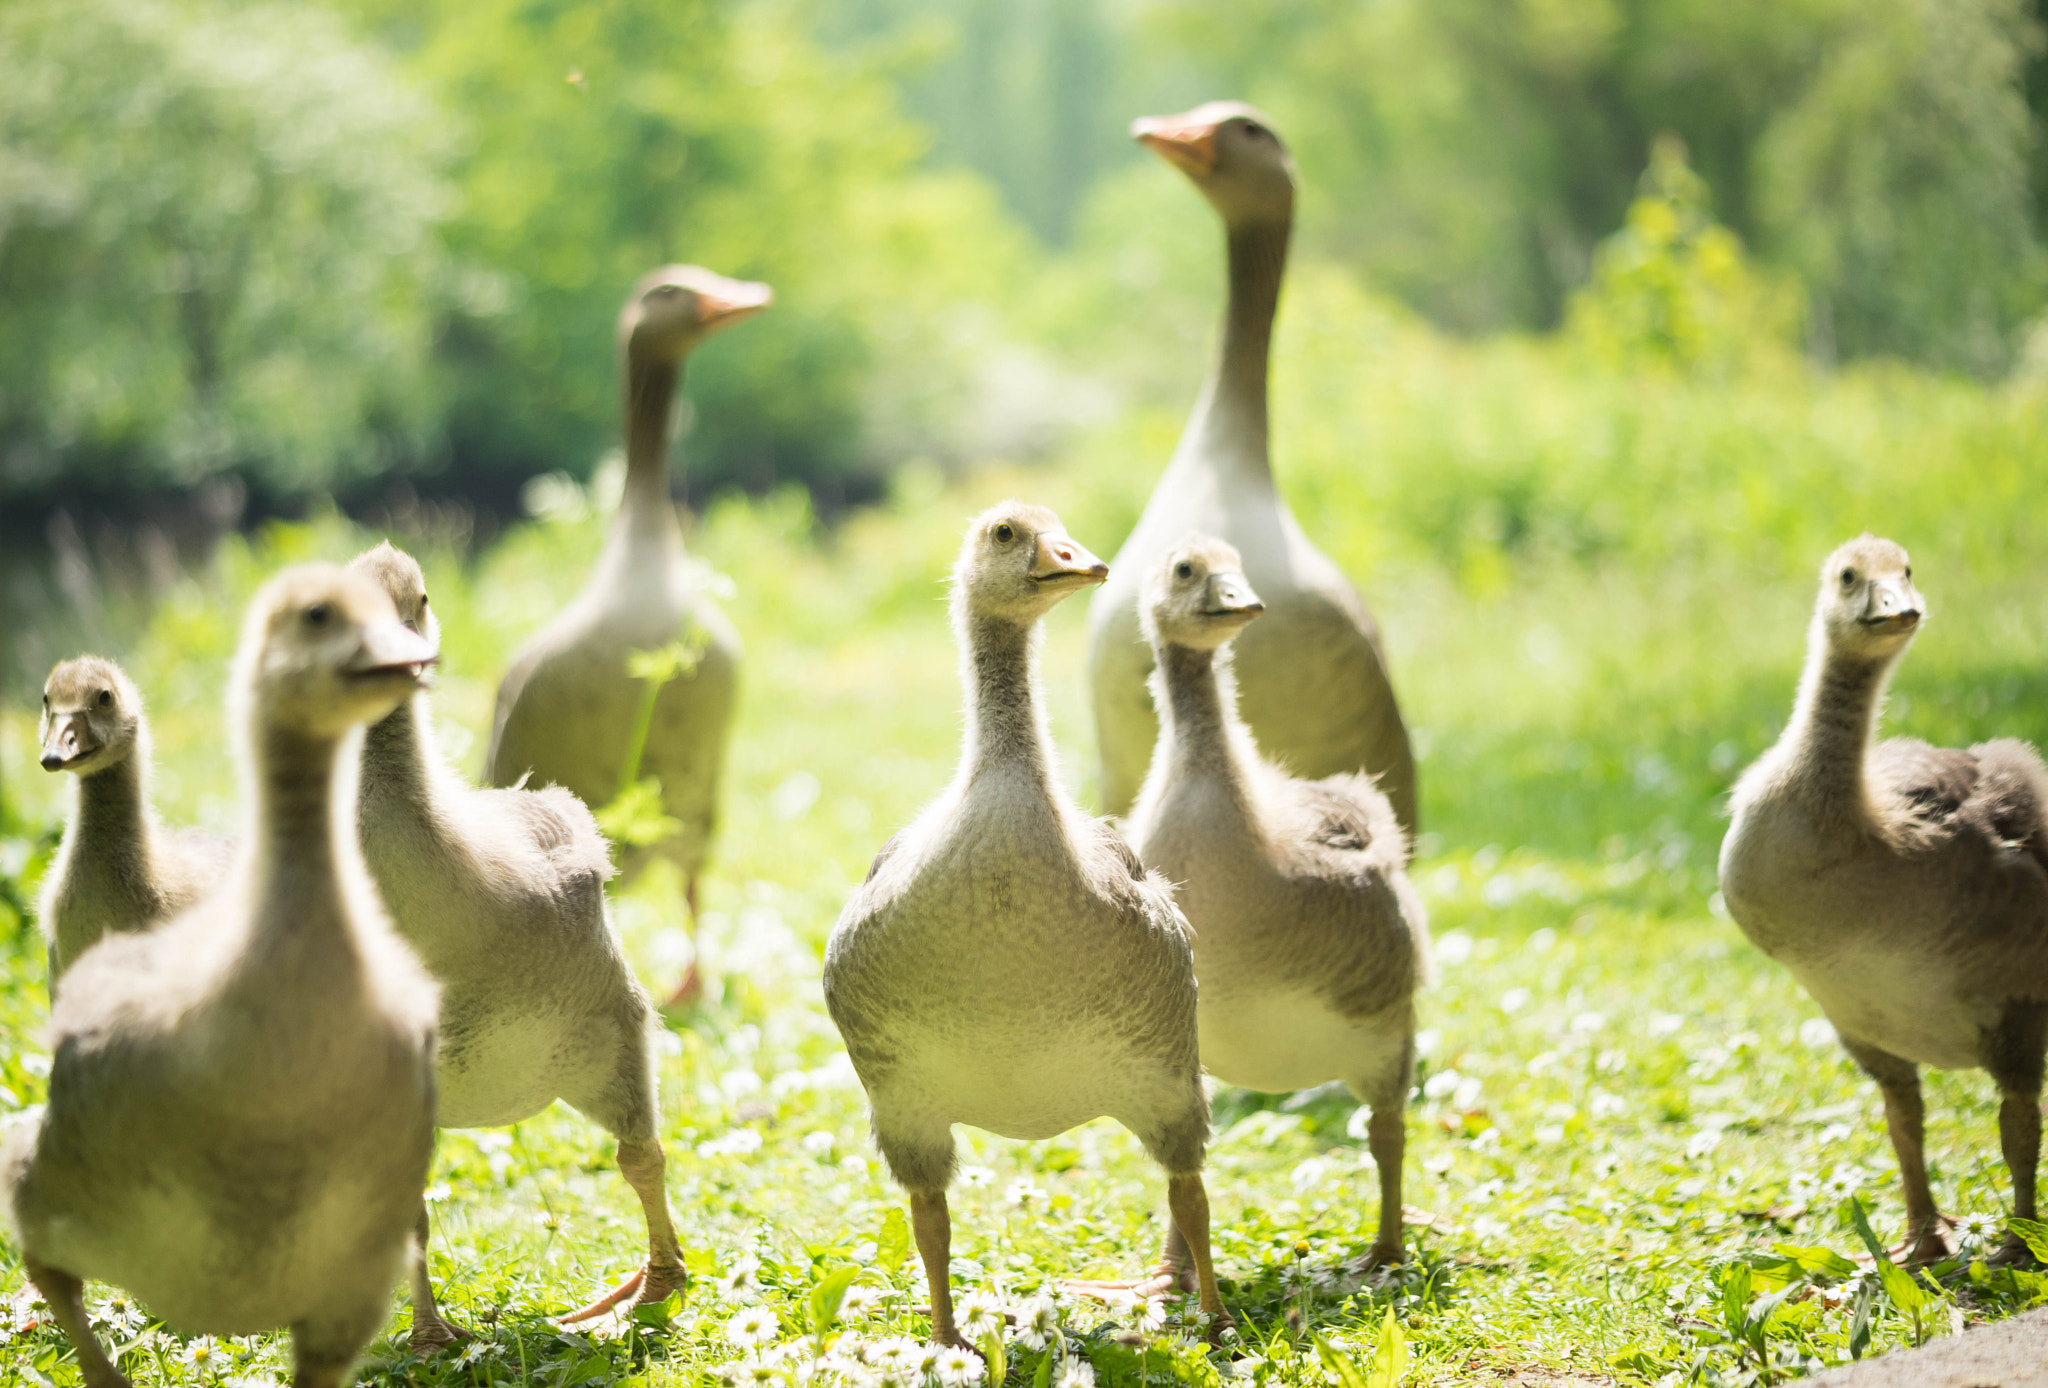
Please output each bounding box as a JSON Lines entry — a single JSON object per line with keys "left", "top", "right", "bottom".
{"left": 825, "top": 502, "right": 1227, "bottom": 1343}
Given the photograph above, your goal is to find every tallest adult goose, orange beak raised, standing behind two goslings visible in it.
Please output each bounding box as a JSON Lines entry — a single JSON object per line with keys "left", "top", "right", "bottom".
{"left": 1087, "top": 102, "right": 1415, "bottom": 833}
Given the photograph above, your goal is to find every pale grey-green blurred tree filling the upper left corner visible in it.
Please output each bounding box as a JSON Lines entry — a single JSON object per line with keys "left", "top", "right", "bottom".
{"left": 0, "top": 0, "right": 446, "bottom": 500}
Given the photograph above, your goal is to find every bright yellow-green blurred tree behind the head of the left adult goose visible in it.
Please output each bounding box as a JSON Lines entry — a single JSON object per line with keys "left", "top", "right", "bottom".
{"left": 352, "top": 0, "right": 1026, "bottom": 508}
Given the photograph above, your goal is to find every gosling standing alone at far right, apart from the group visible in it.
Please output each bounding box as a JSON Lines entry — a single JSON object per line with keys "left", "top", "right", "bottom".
{"left": 1720, "top": 534, "right": 2048, "bottom": 1263}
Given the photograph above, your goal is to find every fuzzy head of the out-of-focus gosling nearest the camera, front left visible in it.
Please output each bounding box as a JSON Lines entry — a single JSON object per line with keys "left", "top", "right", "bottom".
{"left": 236, "top": 563, "right": 434, "bottom": 737}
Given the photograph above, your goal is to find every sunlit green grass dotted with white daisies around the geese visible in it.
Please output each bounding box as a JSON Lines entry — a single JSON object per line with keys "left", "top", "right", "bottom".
{"left": 0, "top": 307, "right": 2048, "bottom": 1388}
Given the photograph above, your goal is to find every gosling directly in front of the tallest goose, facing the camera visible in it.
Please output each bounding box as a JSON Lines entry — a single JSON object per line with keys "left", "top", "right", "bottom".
{"left": 1128, "top": 534, "right": 1430, "bottom": 1286}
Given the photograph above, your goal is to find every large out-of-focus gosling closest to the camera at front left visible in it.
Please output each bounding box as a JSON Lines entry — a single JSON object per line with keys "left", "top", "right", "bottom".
{"left": 0, "top": 565, "right": 434, "bottom": 1388}
